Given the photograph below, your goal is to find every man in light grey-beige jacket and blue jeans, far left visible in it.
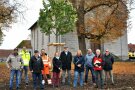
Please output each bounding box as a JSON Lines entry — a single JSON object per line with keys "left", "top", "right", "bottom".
{"left": 6, "top": 48, "right": 24, "bottom": 90}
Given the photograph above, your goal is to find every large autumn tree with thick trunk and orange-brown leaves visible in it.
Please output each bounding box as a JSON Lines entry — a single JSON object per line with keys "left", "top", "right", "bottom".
{"left": 70, "top": 0, "right": 132, "bottom": 54}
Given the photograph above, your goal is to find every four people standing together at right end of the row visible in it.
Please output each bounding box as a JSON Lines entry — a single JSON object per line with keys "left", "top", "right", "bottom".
{"left": 73, "top": 49, "right": 114, "bottom": 89}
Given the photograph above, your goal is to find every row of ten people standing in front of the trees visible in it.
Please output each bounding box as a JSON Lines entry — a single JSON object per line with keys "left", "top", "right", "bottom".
{"left": 6, "top": 47, "right": 114, "bottom": 90}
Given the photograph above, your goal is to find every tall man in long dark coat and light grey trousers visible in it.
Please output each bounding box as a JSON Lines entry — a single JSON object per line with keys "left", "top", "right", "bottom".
{"left": 60, "top": 47, "right": 72, "bottom": 85}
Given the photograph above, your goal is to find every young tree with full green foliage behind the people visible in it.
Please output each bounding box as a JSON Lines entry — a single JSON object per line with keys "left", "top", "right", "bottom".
{"left": 38, "top": 0, "right": 77, "bottom": 50}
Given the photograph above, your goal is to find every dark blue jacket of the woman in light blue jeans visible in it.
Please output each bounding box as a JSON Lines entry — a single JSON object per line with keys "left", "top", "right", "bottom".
{"left": 73, "top": 56, "right": 85, "bottom": 72}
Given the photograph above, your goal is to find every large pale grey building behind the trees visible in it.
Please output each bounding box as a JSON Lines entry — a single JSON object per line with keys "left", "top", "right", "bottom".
{"left": 29, "top": 22, "right": 128, "bottom": 60}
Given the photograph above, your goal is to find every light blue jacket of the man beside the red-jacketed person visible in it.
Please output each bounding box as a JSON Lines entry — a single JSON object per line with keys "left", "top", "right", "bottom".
{"left": 85, "top": 53, "right": 95, "bottom": 67}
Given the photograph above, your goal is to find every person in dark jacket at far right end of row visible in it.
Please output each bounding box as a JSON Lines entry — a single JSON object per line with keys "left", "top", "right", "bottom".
{"left": 103, "top": 49, "right": 114, "bottom": 85}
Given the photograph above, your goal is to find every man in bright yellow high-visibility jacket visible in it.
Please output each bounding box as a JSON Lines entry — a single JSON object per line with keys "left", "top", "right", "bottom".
{"left": 19, "top": 47, "right": 30, "bottom": 86}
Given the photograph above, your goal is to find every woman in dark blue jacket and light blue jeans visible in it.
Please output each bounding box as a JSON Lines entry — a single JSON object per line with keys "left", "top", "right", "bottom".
{"left": 73, "top": 50, "right": 85, "bottom": 87}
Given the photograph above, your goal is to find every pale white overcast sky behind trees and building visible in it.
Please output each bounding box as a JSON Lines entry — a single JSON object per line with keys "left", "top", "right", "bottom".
{"left": 0, "top": 0, "right": 135, "bottom": 49}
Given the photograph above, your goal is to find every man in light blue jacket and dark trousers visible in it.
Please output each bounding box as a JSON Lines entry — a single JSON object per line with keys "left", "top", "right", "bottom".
{"left": 85, "top": 49, "right": 95, "bottom": 85}
